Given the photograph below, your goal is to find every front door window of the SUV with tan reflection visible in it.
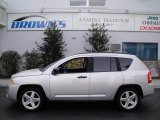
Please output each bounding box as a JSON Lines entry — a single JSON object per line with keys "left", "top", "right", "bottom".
{"left": 59, "top": 58, "right": 88, "bottom": 73}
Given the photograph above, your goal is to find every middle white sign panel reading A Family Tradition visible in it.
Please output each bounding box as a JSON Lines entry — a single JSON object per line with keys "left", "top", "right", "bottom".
{"left": 73, "top": 13, "right": 134, "bottom": 31}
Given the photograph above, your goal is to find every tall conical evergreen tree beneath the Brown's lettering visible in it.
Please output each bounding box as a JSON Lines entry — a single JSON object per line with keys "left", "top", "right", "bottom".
{"left": 36, "top": 22, "right": 66, "bottom": 66}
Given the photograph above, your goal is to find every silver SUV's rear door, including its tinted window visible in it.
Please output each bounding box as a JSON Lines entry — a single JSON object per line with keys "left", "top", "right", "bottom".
{"left": 90, "top": 57, "right": 123, "bottom": 100}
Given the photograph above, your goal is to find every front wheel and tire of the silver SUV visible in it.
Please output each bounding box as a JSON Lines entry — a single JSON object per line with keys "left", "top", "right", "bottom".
{"left": 18, "top": 88, "right": 45, "bottom": 111}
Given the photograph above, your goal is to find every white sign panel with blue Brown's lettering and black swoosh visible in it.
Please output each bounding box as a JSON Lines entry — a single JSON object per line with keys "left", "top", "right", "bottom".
{"left": 8, "top": 14, "right": 72, "bottom": 30}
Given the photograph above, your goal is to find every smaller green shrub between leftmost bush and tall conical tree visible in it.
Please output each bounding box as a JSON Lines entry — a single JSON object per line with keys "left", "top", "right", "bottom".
{"left": 22, "top": 49, "right": 40, "bottom": 70}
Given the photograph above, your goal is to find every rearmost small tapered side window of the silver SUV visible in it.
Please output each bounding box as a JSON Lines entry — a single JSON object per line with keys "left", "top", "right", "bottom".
{"left": 119, "top": 58, "right": 133, "bottom": 71}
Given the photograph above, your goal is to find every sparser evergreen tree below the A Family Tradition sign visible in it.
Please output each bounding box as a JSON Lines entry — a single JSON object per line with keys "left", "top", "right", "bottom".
{"left": 84, "top": 23, "right": 111, "bottom": 52}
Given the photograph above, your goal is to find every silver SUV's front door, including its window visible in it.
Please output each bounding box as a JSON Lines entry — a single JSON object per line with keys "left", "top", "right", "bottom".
{"left": 50, "top": 57, "right": 90, "bottom": 100}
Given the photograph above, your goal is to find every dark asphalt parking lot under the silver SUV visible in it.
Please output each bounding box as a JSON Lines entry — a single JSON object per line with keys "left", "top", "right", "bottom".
{"left": 0, "top": 87, "right": 160, "bottom": 120}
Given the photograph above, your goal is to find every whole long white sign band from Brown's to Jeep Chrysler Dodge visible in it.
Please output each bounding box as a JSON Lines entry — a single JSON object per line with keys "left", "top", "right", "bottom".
{"left": 8, "top": 13, "right": 160, "bottom": 31}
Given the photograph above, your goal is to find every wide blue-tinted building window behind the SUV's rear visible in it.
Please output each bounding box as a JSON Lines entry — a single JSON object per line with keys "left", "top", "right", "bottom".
{"left": 122, "top": 43, "right": 158, "bottom": 61}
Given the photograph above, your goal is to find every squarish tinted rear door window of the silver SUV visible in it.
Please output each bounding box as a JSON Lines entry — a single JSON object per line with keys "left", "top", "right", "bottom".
{"left": 93, "top": 57, "right": 110, "bottom": 72}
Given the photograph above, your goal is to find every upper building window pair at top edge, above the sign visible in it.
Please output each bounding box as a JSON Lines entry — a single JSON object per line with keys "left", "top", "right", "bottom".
{"left": 70, "top": 0, "right": 106, "bottom": 7}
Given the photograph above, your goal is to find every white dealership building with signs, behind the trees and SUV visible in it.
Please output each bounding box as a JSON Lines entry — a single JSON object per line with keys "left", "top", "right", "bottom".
{"left": 0, "top": 0, "right": 160, "bottom": 61}
